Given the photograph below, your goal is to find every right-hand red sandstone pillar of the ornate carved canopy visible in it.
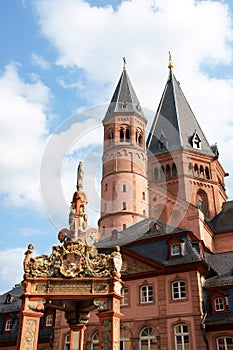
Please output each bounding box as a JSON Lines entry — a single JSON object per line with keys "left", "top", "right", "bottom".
{"left": 98, "top": 297, "right": 122, "bottom": 350}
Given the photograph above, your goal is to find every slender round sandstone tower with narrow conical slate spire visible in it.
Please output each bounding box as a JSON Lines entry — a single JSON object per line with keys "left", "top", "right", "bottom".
{"left": 99, "top": 60, "right": 148, "bottom": 238}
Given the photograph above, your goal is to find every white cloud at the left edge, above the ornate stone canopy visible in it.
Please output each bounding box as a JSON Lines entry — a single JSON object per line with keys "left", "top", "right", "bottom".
{"left": 0, "top": 63, "right": 50, "bottom": 206}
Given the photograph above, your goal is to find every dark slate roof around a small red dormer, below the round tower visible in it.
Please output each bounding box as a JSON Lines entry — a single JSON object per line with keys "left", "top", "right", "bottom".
{"left": 96, "top": 218, "right": 211, "bottom": 267}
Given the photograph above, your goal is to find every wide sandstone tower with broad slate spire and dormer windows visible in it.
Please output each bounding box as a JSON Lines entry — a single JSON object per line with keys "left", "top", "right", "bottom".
{"left": 147, "top": 57, "right": 227, "bottom": 224}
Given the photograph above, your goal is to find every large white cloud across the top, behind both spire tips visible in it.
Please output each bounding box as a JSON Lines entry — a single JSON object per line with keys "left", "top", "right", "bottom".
{"left": 33, "top": 0, "right": 233, "bottom": 197}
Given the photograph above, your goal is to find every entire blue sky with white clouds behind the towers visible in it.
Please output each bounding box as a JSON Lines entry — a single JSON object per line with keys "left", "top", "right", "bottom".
{"left": 0, "top": 0, "right": 233, "bottom": 292}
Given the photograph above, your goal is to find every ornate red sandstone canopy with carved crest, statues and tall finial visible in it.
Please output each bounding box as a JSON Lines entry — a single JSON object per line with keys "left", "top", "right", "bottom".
{"left": 17, "top": 162, "right": 122, "bottom": 350}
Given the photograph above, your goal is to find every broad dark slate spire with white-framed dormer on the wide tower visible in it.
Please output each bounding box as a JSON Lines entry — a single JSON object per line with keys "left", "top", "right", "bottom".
{"left": 147, "top": 54, "right": 214, "bottom": 156}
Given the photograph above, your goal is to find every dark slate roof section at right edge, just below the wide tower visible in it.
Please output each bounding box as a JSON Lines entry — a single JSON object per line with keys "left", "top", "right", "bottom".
{"left": 207, "top": 201, "right": 233, "bottom": 234}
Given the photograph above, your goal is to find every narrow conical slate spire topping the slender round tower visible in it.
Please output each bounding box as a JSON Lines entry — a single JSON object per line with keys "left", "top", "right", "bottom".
{"left": 105, "top": 58, "right": 144, "bottom": 119}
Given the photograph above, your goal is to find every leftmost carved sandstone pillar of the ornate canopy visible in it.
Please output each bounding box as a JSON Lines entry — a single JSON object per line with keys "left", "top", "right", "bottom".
{"left": 17, "top": 311, "right": 43, "bottom": 350}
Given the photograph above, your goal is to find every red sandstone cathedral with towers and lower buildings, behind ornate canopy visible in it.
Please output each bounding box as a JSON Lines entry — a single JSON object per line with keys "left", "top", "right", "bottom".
{"left": 0, "top": 60, "right": 233, "bottom": 350}
